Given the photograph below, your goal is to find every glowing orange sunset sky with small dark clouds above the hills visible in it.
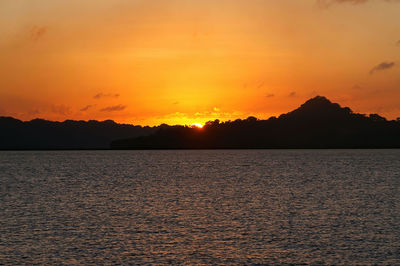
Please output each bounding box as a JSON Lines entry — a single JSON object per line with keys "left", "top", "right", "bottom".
{"left": 0, "top": 0, "right": 400, "bottom": 126}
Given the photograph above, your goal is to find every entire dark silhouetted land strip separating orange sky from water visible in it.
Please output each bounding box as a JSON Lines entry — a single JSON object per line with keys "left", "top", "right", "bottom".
{"left": 0, "top": 96, "right": 400, "bottom": 150}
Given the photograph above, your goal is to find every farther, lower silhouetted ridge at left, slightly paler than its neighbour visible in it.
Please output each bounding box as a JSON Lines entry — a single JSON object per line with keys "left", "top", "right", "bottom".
{"left": 0, "top": 117, "right": 156, "bottom": 150}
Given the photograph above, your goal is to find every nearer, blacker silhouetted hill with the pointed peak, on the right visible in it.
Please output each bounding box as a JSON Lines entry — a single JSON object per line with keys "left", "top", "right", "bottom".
{"left": 111, "top": 96, "right": 400, "bottom": 149}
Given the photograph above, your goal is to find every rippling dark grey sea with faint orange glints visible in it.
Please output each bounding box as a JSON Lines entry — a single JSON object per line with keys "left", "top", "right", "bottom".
{"left": 0, "top": 150, "right": 400, "bottom": 265}
